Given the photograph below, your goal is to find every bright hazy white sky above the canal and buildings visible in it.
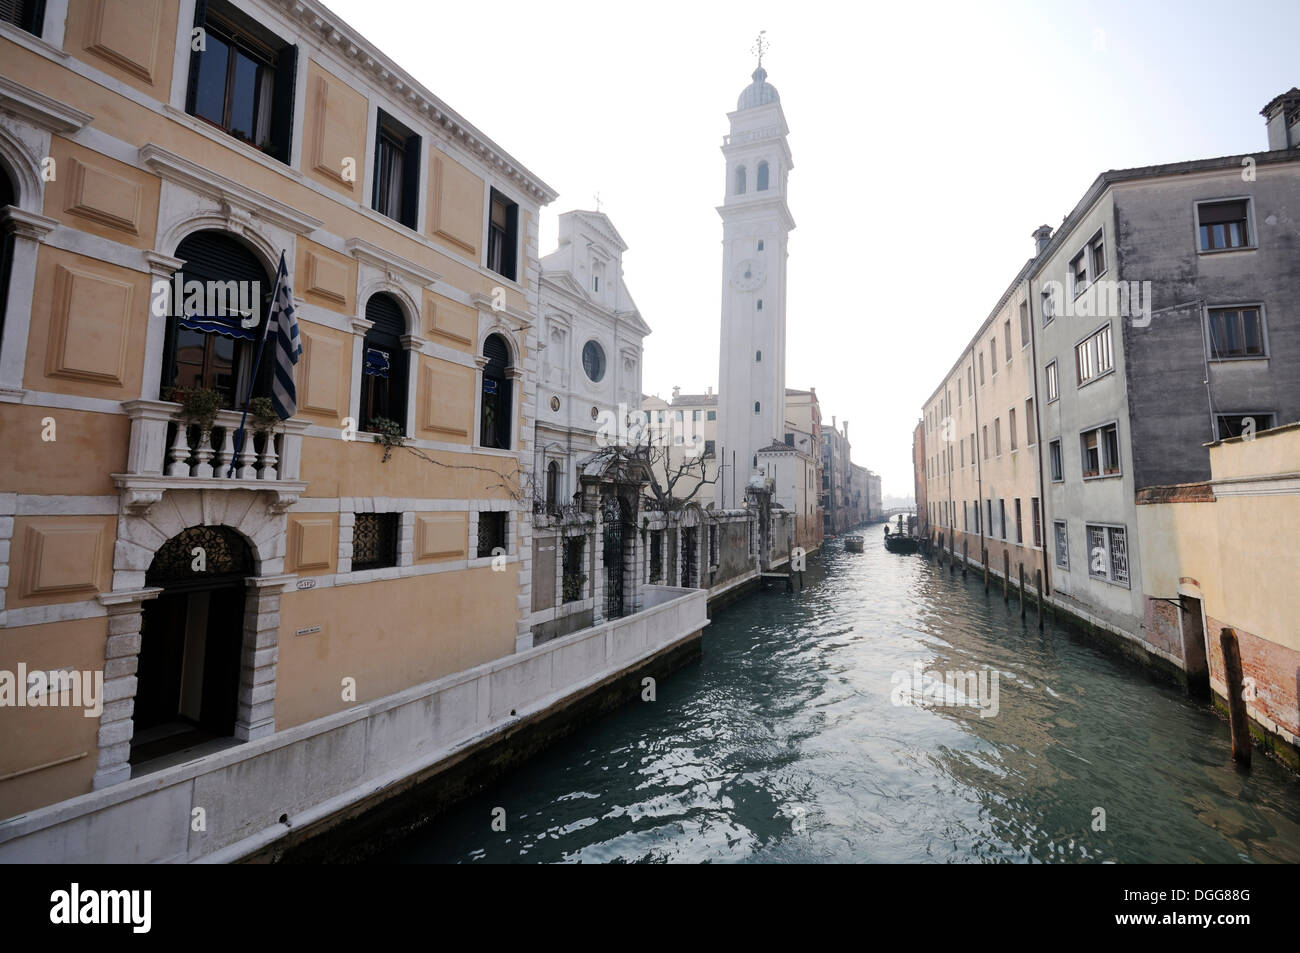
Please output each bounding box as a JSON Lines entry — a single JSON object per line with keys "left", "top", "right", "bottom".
{"left": 319, "top": 0, "right": 1300, "bottom": 497}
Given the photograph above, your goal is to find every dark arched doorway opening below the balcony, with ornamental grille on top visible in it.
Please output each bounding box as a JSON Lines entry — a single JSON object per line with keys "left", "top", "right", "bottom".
{"left": 130, "top": 527, "right": 255, "bottom": 767}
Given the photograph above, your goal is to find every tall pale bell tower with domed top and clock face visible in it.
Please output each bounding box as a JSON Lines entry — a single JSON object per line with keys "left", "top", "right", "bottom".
{"left": 715, "top": 34, "right": 794, "bottom": 508}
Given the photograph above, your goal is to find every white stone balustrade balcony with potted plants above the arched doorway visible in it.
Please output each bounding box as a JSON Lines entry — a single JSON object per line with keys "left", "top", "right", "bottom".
{"left": 113, "top": 400, "right": 307, "bottom": 515}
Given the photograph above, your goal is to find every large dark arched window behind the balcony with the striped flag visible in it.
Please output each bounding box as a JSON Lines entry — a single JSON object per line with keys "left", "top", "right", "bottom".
{"left": 160, "top": 231, "right": 276, "bottom": 407}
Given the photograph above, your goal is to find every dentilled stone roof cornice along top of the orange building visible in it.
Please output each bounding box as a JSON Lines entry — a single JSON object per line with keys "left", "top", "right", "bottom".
{"left": 274, "top": 0, "right": 559, "bottom": 205}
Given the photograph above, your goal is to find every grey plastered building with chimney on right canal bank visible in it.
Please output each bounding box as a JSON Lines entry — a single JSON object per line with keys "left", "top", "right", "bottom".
{"left": 1022, "top": 88, "right": 1300, "bottom": 639}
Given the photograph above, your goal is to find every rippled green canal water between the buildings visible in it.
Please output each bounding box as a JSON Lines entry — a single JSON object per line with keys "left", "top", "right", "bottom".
{"left": 380, "top": 527, "right": 1300, "bottom": 863}
